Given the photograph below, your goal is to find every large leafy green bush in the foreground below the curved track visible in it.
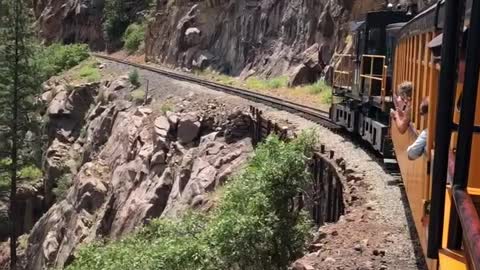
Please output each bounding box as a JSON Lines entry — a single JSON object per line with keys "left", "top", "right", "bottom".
{"left": 67, "top": 134, "right": 314, "bottom": 270}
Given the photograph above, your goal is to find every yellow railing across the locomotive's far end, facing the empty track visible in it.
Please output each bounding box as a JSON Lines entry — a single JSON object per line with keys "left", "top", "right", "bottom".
{"left": 333, "top": 53, "right": 355, "bottom": 89}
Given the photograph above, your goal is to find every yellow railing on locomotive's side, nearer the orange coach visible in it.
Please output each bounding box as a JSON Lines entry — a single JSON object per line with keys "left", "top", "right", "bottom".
{"left": 360, "top": 54, "right": 388, "bottom": 105}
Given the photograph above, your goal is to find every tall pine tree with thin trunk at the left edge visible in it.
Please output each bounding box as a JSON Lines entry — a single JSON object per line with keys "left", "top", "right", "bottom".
{"left": 0, "top": 0, "right": 40, "bottom": 269}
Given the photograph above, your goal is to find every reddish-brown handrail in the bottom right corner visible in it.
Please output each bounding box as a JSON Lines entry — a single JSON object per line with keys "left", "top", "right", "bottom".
{"left": 453, "top": 188, "right": 480, "bottom": 270}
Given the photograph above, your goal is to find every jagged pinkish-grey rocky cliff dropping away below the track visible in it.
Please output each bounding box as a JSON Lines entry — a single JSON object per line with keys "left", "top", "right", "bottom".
{"left": 26, "top": 75, "right": 253, "bottom": 269}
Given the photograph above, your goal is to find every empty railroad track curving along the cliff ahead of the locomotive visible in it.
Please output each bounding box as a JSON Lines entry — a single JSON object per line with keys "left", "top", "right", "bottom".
{"left": 92, "top": 53, "right": 340, "bottom": 130}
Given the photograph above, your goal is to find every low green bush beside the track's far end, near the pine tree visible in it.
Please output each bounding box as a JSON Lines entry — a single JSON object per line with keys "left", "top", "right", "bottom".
{"left": 35, "top": 44, "right": 90, "bottom": 81}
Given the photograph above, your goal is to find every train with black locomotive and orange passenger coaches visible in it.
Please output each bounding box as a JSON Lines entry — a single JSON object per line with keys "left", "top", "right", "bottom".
{"left": 330, "top": 0, "right": 480, "bottom": 270}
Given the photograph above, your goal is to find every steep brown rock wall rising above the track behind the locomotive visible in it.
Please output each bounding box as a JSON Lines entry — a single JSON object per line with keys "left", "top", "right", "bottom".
{"left": 146, "top": 0, "right": 434, "bottom": 78}
